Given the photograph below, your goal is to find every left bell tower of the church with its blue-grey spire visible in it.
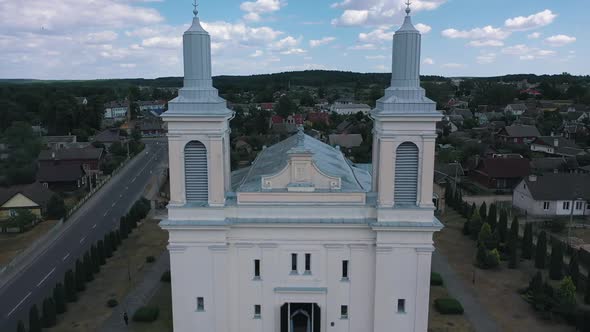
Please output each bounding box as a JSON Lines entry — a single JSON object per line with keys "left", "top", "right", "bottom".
{"left": 162, "top": 0, "right": 233, "bottom": 209}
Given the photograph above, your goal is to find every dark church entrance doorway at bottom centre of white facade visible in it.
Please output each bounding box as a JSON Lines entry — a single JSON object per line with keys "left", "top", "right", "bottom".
{"left": 281, "top": 303, "right": 321, "bottom": 332}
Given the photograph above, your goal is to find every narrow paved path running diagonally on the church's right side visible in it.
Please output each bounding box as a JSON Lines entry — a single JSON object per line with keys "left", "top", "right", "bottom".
{"left": 432, "top": 251, "right": 500, "bottom": 332}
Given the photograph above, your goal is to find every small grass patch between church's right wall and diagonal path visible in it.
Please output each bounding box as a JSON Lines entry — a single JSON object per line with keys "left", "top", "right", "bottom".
{"left": 428, "top": 286, "right": 475, "bottom": 332}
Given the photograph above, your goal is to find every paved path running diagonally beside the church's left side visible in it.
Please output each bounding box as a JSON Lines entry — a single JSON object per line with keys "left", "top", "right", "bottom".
{"left": 99, "top": 250, "right": 170, "bottom": 332}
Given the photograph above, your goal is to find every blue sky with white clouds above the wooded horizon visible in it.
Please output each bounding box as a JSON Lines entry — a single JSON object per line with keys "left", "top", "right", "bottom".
{"left": 0, "top": 0, "right": 590, "bottom": 79}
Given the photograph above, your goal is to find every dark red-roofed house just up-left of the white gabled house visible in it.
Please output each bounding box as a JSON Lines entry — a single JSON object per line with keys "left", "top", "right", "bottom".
{"left": 470, "top": 157, "right": 531, "bottom": 190}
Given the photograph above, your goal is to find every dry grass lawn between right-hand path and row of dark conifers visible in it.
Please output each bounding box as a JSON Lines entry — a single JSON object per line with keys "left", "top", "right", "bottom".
{"left": 435, "top": 209, "right": 574, "bottom": 332}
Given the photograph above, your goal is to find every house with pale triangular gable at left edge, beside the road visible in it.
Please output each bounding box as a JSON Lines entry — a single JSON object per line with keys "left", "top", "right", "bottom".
{"left": 0, "top": 182, "right": 53, "bottom": 221}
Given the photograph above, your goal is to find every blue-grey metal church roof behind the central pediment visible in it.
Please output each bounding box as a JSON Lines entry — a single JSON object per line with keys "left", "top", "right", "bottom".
{"left": 232, "top": 134, "right": 371, "bottom": 192}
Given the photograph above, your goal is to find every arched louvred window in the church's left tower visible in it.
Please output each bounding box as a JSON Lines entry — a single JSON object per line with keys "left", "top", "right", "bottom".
{"left": 184, "top": 141, "right": 209, "bottom": 202}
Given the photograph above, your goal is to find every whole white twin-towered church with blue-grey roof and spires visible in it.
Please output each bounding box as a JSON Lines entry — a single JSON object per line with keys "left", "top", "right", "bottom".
{"left": 161, "top": 3, "right": 442, "bottom": 332}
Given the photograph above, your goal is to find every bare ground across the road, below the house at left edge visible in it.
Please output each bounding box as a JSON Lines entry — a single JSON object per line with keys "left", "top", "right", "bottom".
{"left": 0, "top": 220, "right": 58, "bottom": 266}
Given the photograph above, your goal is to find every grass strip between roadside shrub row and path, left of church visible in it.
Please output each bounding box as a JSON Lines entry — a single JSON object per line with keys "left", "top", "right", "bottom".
{"left": 43, "top": 220, "right": 168, "bottom": 332}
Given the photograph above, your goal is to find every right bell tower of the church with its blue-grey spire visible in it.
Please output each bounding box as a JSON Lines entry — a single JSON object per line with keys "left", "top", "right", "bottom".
{"left": 371, "top": 1, "right": 441, "bottom": 211}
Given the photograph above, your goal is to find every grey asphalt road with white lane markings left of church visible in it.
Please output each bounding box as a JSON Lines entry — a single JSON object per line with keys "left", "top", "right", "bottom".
{"left": 0, "top": 141, "right": 168, "bottom": 332}
